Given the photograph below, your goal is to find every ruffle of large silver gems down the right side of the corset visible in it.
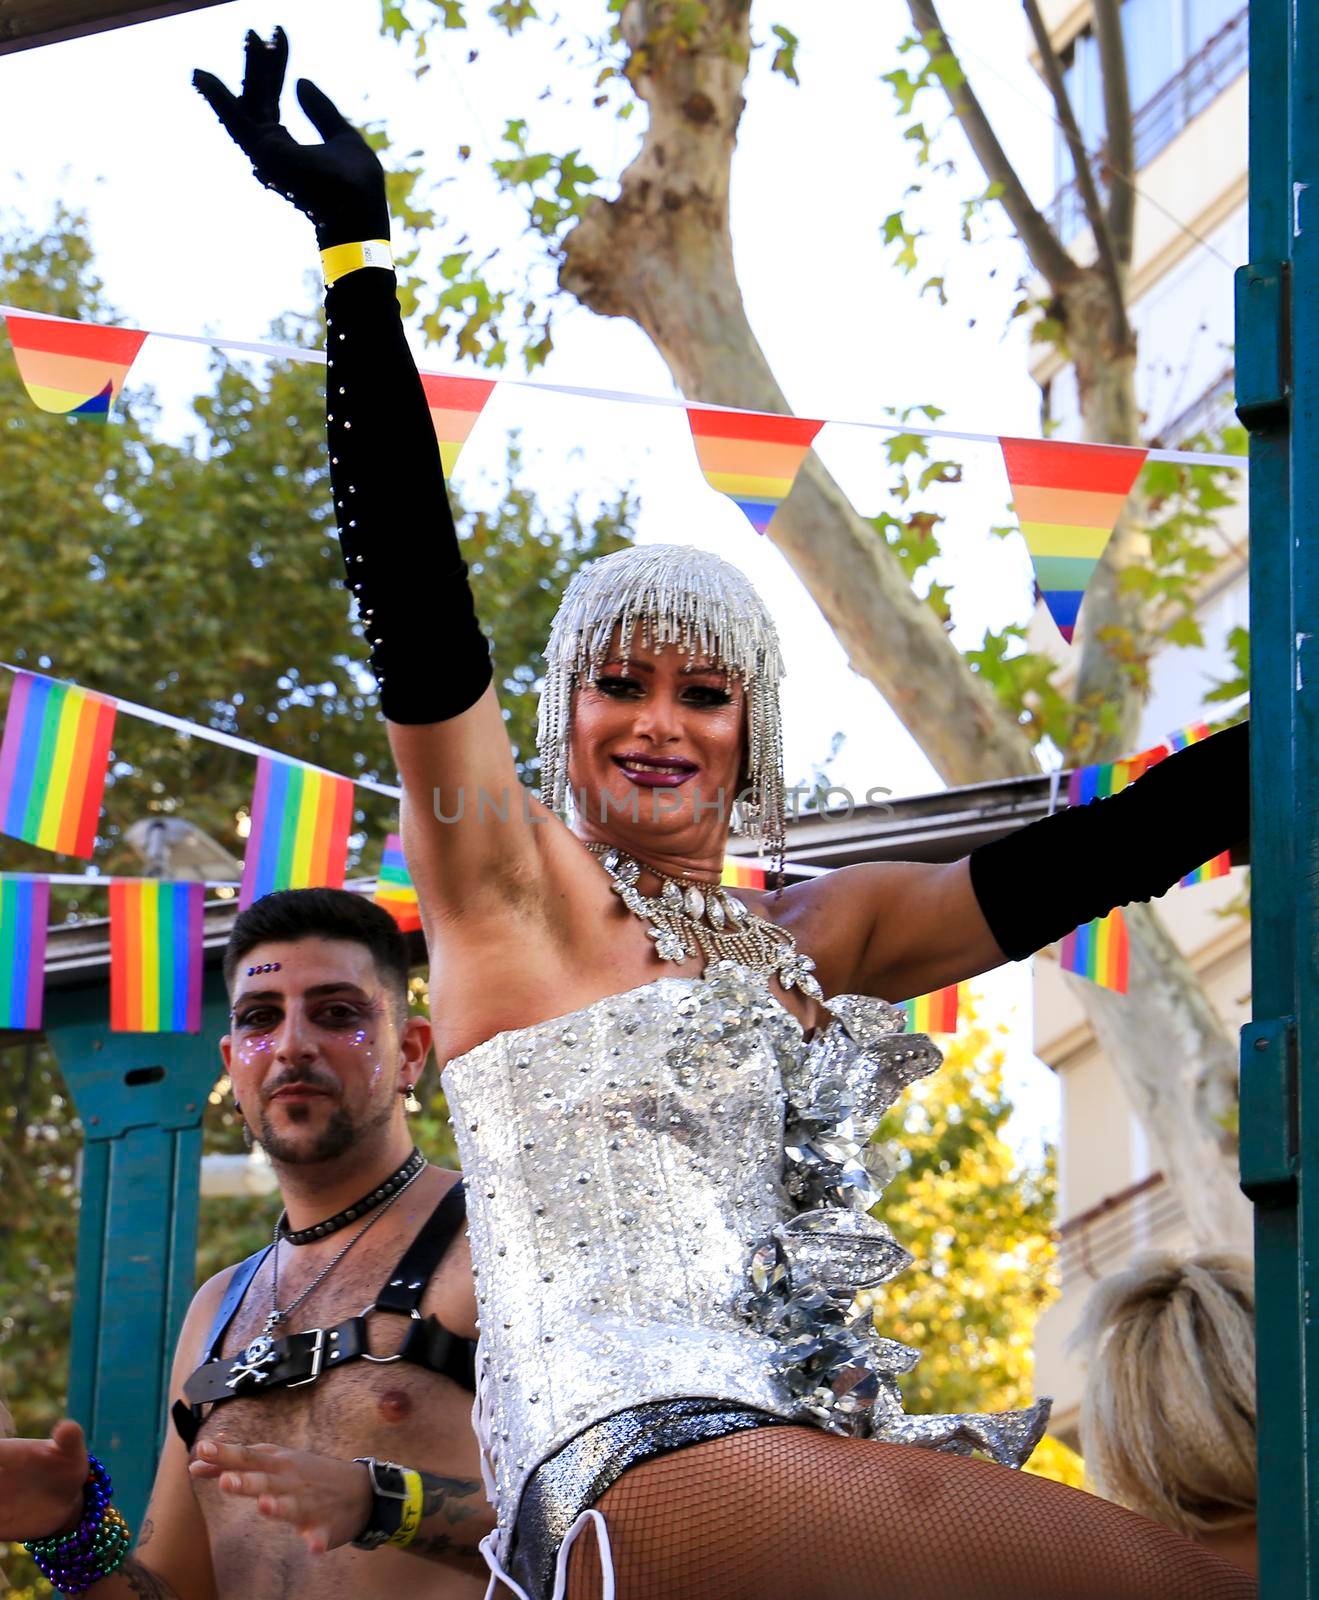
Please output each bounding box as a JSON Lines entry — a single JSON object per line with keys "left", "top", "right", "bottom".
{"left": 744, "top": 995, "right": 1050, "bottom": 1467}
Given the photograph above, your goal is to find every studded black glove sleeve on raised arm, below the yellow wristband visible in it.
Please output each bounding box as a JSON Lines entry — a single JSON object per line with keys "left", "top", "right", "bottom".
{"left": 325, "top": 267, "right": 491, "bottom": 723}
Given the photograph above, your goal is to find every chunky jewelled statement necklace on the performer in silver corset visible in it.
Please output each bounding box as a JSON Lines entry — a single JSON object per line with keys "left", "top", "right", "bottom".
{"left": 586, "top": 845, "right": 824, "bottom": 1000}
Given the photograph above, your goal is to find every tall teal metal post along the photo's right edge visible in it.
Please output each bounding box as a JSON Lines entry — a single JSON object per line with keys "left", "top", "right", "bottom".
{"left": 1237, "top": 0, "right": 1319, "bottom": 1600}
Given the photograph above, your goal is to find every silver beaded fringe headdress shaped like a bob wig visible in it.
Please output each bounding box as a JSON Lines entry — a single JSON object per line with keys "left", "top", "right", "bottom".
{"left": 536, "top": 544, "right": 784, "bottom": 858}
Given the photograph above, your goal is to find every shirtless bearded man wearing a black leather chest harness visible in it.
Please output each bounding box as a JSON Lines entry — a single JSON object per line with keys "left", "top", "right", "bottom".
{"left": 0, "top": 890, "right": 493, "bottom": 1600}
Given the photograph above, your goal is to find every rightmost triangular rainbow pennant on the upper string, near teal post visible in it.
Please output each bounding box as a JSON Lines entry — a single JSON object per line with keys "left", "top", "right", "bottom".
{"left": 999, "top": 437, "right": 1148, "bottom": 643}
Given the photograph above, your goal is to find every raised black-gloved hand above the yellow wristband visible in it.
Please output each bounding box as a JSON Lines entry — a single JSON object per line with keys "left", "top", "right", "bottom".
{"left": 192, "top": 27, "right": 389, "bottom": 250}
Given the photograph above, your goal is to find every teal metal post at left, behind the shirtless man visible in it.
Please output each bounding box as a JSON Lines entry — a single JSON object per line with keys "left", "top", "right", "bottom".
{"left": 45, "top": 968, "right": 229, "bottom": 1528}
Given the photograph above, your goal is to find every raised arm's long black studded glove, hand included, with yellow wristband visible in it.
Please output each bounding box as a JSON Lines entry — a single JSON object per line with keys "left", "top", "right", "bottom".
{"left": 192, "top": 29, "right": 491, "bottom": 723}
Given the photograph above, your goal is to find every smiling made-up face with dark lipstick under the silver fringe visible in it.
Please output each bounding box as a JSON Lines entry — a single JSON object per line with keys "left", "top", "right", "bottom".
{"left": 568, "top": 624, "right": 746, "bottom": 856}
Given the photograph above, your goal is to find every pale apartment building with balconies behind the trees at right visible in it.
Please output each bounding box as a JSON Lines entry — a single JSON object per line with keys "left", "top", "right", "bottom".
{"left": 1034, "top": 0, "right": 1250, "bottom": 1442}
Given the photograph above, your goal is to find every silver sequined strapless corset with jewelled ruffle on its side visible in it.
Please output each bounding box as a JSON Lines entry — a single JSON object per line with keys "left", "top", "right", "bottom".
{"left": 445, "top": 963, "right": 1042, "bottom": 1542}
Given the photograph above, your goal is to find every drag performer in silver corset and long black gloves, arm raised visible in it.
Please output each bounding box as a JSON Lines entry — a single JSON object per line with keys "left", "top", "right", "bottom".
{"left": 195, "top": 32, "right": 1253, "bottom": 1600}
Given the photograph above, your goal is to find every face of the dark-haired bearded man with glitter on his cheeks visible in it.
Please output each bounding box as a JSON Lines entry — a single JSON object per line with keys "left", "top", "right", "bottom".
{"left": 221, "top": 938, "right": 429, "bottom": 1165}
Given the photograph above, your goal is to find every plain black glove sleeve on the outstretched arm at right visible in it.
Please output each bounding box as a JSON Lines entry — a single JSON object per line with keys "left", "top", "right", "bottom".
{"left": 970, "top": 722, "right": 1250, "bottom": 962}
